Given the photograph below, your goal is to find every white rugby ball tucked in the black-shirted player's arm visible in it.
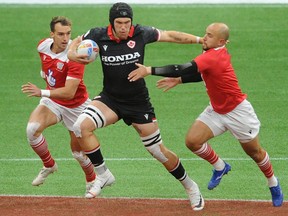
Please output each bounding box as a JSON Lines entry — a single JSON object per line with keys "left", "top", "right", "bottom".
{"left": 77, "top": 39, "right": 99, "bottom": 61}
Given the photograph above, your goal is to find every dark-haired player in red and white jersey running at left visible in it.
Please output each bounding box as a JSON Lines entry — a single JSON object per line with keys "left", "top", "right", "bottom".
{"left": 22, "top": 16, "right": 96, "bottom": 195}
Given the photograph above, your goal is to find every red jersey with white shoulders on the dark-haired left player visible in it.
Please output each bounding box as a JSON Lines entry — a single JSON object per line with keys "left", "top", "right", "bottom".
{"left": 37, "top": 38, "right": 89, "bottom": 108}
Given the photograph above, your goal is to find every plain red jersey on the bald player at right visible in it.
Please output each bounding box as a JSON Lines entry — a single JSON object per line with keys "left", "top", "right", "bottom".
{"left": 194, "top": 47, "right": 247, "bottom": 114}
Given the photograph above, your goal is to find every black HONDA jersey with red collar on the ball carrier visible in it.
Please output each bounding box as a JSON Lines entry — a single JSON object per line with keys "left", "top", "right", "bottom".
{"left": 83, "top": 25, "right": 159, "bottom": 103}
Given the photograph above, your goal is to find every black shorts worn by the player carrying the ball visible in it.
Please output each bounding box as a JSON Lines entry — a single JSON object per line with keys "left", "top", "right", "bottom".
{"left": 93, "top": 92, "right": 156, "bottom": 125}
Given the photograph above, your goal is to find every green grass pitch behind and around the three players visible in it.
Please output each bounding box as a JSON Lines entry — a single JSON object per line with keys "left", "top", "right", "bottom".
{"left": 0, "top": 5, "right": 288, "bottom": 200}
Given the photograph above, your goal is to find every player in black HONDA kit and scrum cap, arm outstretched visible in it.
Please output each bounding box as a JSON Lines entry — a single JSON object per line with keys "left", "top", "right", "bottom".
{"left": 68, "top": 2, "right": 204, "bottom": 210}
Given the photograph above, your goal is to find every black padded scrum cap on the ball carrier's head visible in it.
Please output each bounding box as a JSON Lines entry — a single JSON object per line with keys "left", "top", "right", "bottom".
{"left": 109, "top": 2, "right": 133, "bottom": 25}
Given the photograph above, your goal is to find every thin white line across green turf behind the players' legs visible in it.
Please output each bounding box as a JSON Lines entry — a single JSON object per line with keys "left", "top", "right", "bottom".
{"left": 0, "top": 157, "right": 288, "bottom": 162}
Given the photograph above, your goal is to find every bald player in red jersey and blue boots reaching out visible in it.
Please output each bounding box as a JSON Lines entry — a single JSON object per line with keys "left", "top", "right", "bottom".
{"left": 128, "top": 23, "right": 283, "bottom": 206}
